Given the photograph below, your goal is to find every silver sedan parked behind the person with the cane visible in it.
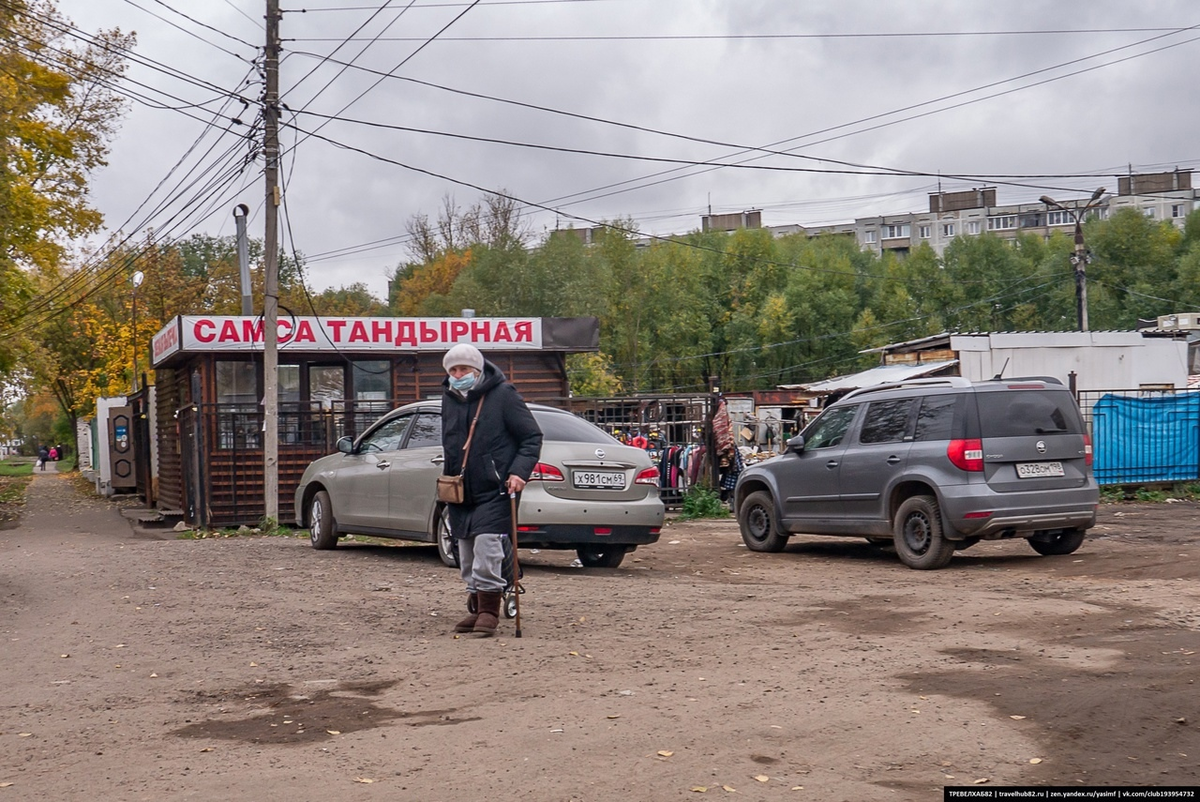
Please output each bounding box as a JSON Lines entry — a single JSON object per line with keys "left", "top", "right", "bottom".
{"left": 295, "top": 401, "right": 664, "bottom": 568}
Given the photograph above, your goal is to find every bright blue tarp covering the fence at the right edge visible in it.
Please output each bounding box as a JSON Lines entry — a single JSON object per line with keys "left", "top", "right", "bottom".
{"left": 1080, "top": 391, "right": 1200, "bottom": 485}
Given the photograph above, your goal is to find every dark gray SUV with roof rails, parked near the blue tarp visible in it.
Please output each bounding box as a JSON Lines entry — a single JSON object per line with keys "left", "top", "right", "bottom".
{"left": 733, "top": 376, "right": 1099, "bottom": 569}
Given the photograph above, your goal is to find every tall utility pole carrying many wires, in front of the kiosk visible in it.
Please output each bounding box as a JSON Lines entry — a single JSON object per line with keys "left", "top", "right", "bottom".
{"left": 263, "top": 0, "right": 280, "bottom": 522}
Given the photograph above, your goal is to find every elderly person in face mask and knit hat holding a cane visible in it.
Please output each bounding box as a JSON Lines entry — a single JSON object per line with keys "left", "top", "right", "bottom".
{"left": 442, "top": 343, "right": 542, "bottom": 638}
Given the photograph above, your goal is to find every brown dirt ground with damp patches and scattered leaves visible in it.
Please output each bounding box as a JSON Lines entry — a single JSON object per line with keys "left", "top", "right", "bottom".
{"left": 0, "top": 473, "right": 1200, "bottom": 802}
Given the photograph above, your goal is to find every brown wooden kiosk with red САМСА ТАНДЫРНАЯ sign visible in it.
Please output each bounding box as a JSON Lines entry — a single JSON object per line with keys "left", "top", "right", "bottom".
{"left": 151, "top": 315, "right": 600, "bottom": 527}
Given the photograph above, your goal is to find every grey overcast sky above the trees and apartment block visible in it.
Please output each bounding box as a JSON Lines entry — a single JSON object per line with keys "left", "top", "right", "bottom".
{"left": 51, "top": 0, "right": 1200, "bottom": 298}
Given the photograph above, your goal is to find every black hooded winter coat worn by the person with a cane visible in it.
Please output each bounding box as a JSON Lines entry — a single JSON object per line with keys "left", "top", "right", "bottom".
{"left": 442, "top": 360, "right": 541, "bottom": 538}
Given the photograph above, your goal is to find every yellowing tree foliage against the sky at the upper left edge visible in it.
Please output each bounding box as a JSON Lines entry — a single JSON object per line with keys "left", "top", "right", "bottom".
{"left": 0, "top": 0, "right": 134, "bottom": 370}
